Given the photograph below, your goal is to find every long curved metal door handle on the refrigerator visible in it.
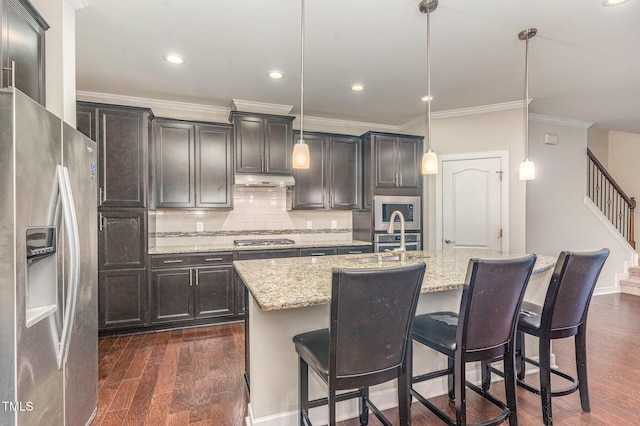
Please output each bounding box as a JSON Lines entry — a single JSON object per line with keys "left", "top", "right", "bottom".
{"left": 56, "top": 166, "right": 80, "bottom": 369}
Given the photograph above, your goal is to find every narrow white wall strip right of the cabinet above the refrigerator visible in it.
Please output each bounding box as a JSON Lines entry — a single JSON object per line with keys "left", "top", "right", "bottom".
{"left": 31, "top": 0, "right": 76, "bottom": 126}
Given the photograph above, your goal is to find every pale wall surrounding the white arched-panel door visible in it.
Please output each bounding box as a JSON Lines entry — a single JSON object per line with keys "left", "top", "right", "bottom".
{"left": 407, "top": 108, "right": 525, "bottom": 252}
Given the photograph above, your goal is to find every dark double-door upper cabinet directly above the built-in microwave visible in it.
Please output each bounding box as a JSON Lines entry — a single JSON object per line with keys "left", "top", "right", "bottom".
{"left": 361, "top": 132, "right": 423, "bottom": 209}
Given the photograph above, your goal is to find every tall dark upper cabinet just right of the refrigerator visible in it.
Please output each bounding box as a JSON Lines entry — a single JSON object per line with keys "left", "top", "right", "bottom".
{"left": 76, "top": 102, "right": 151, "bottom": 208}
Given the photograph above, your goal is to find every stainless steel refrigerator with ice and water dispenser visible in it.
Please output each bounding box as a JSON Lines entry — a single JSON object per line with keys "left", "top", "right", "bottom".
{"left": 0, "top": 88, "right": 98, "bottom": 426}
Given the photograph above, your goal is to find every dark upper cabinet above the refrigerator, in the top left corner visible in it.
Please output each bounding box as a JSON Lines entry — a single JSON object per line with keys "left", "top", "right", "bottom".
{"left": 0, "top": 0, "right": 49, "bottom": 105}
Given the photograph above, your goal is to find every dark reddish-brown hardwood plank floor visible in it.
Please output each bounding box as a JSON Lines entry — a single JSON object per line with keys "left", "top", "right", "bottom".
{"left": 92, "top": 294, "right": 640, "bottom": 426}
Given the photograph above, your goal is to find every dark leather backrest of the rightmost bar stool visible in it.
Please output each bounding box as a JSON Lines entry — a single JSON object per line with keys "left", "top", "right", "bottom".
{"left": 541, "top": 248, "right": 609, "bottom": 338}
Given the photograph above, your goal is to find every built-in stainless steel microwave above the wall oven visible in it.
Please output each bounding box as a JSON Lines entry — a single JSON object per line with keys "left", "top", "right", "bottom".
{"left": 373, "top": 195, "right": 422, "bottom": 231}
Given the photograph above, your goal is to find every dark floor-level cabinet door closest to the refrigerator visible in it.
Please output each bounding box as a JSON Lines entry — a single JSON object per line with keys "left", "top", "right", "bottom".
{"left": 98, "top": 268, "right": 147, "bottom": 330}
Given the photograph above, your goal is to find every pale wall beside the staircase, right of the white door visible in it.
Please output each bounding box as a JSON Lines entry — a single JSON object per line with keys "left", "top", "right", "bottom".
{"left": 526, "top": 121, "right": 635, "bottom": 293}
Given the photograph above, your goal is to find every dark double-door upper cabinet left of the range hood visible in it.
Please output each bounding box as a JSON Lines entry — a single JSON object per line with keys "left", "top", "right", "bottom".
{"left": 153, "top": 119, "right": 233, "bottom": 210}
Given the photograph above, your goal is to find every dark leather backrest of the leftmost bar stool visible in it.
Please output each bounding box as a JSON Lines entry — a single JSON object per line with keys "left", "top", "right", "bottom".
{"left": 329, "top": 262, "right": 425, "bottom": 388}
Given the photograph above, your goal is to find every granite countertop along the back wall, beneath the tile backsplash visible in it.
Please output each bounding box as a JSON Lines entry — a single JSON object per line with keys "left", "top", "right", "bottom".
{"left": 149, "top": 240, "right": 371, "bottom": 254}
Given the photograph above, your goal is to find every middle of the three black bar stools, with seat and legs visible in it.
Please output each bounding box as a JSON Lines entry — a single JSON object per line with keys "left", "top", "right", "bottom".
{"left": 411, "top": 255, "right": 536, "bottom": 426}
